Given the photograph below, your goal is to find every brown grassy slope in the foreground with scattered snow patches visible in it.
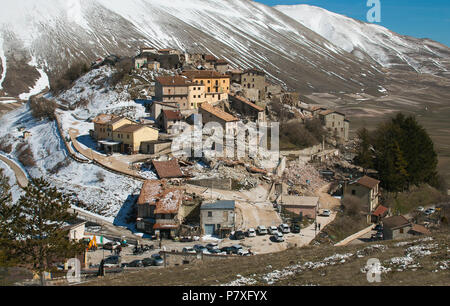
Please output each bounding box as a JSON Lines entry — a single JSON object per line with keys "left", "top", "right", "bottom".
{"left": 84, "top": 232, "right": 450, "bottom": 286}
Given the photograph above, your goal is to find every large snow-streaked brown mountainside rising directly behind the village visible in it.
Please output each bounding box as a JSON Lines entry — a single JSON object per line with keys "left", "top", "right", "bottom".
{"left": 0, "top": 0, "right": 383, "bottom": 96}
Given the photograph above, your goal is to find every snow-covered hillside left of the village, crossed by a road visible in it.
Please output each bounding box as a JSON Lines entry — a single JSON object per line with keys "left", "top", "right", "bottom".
{"left": 0, "top": 67, "right": 152, "bottom": 219}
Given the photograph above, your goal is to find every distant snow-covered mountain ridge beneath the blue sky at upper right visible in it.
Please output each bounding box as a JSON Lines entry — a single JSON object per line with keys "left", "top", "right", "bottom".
{"left": 275, "top": 4, "right": 450, "bottom": 76}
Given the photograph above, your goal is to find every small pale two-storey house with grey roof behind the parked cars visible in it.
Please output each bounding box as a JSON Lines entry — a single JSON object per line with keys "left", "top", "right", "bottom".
{"left": 200, "top": 200, "right": 236, "bottom": 238}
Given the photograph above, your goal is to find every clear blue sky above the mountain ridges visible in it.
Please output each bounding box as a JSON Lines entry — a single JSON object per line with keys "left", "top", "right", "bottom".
{"left": 255, "top": 0, "right": 450, "bottom": 46}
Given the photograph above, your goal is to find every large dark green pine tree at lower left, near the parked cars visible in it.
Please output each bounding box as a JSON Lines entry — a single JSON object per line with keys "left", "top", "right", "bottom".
{"left": 2, "top": 179, "right": 83, "bottom": 284}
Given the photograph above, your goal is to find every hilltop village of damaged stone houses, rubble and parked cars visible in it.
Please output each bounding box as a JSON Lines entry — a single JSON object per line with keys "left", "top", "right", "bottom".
{"left": 0, "top": 47, "right": 446, "bottom": 284}
